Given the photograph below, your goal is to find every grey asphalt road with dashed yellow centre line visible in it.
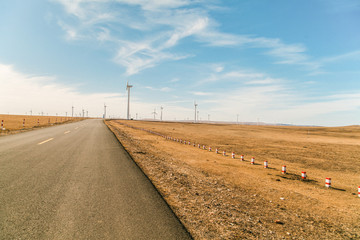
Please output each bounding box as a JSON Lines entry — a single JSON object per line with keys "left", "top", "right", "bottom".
{"left": 0, "top": 120, "right": 191, "bottom": 239}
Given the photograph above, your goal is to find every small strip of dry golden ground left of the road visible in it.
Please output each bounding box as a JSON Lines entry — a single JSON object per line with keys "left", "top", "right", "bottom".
{"left": 0, "top": 114, "right": 84, "bottom": 135}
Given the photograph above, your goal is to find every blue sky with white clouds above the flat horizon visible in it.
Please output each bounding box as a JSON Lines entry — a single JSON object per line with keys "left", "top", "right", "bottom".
{"left": 0, "top": 0, "right": 360, "bottom": 126}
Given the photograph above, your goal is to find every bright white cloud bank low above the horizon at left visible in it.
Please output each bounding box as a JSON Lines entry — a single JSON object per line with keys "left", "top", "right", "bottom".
{"left": 0, "top": 64, "right": 125, "bottom": 116}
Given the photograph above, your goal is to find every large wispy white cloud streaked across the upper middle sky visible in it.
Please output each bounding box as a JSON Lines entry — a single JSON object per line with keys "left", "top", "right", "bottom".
{"left": 57, "top": 0, "right": 321, "bottom": 75}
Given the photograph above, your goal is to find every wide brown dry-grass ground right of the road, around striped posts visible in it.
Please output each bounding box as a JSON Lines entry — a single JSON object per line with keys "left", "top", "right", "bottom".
{"left": 106, "top": 120, "right": 360, "bottom": 239}
